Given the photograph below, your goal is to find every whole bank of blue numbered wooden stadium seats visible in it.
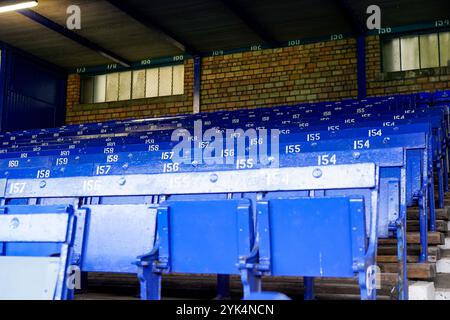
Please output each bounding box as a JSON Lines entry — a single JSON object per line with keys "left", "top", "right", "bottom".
{"left": 0, "top": 92, "right": 450, "bottom": 299}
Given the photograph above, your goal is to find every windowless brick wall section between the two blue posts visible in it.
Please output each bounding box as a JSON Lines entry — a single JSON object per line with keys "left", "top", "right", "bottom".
{"left": 201, "top": 39, "right": 358, "bottom": 111}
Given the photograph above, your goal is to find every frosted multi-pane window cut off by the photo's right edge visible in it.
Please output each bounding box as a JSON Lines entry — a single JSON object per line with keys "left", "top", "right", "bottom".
{"left": 382, "top": 32, "right": 450, "bottom": 72}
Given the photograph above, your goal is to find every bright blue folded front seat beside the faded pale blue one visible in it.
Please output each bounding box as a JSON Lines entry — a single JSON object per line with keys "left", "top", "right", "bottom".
{"left": 157, "top": 199, "right": 254, "bottom": 274}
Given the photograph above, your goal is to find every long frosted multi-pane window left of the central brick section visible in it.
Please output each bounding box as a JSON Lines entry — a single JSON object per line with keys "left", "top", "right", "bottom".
{"left": 81, "top": 65, "right": 184, "bottom": 103}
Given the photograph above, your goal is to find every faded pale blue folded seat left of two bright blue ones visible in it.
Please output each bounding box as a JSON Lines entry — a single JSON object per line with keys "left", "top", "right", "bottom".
{"left": 77, "top": 204, "right": 156, "bottom": 273}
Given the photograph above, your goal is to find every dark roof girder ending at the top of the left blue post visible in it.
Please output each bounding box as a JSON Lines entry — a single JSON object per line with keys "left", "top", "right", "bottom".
{"left": 106, "top": 0, "right": 198, "bottom": 55}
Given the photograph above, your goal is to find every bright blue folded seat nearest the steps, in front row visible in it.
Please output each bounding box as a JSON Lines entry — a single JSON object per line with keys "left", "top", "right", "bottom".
{"left": 257, "top": 197, "right": 366, "bottom": 277}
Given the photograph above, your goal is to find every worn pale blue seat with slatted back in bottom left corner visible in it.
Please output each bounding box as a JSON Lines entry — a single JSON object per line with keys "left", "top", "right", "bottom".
{"left": 0, "top": 206, "right": 75, "bottom": 300}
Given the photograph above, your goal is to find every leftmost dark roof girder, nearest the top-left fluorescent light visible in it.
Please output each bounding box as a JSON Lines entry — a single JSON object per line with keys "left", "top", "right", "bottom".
{"left": 17, "top": 10, "right": 131, "bottom": 67}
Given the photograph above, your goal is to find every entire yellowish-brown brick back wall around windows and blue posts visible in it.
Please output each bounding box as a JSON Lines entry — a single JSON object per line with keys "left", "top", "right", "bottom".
{"left": 67, "top": 36, "right": 450, "bottom": 124}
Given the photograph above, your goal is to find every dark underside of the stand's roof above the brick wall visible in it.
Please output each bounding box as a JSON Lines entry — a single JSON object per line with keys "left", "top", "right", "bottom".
{"left": 0, "top": 0, "right": 450, "bottom": 68}
